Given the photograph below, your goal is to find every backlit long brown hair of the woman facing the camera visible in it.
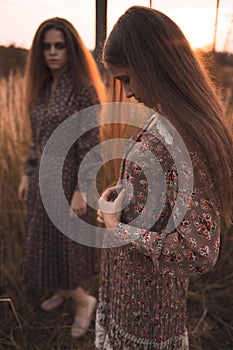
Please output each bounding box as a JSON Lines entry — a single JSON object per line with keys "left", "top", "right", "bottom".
{"left": 26, "top": 17, "right": 105, "bottom": 110}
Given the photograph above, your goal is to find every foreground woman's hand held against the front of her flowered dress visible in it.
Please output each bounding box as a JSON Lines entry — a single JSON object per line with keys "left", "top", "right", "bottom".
{"left": 97, "top": 186, "right": 125, "bottom": 228}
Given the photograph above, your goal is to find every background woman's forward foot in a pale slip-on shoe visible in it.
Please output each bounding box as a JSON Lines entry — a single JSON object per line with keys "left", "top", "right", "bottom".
{"left": 71, "top": 294, "right": 97, "bottom": 338}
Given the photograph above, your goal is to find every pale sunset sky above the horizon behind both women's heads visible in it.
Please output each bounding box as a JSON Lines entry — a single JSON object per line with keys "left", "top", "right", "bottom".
{"left": 0, "top": 0, "right": 233, "bottom": 52}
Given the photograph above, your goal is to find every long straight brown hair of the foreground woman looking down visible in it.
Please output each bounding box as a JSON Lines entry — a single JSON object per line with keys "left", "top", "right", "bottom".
{"left": 103, "top": 6, "right": 233, "bottom": 224}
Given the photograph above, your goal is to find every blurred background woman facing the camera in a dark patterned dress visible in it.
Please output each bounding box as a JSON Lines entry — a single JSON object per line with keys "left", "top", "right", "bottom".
{"left": 19, "top": 17, "right": 105, "bottom": 337}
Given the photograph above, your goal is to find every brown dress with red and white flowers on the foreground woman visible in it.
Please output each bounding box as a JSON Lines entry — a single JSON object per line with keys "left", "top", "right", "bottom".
{"left": 95, "top": 113, "right": 220, "bottom": 350}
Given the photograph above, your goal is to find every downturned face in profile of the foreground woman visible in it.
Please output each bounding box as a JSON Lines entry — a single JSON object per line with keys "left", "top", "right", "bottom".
{"left": 108, "top": 64, "right": 155, "bottom": 108}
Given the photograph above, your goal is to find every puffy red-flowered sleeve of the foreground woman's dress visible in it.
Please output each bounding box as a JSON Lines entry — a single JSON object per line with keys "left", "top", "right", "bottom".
{"left": 116, "top": 130, "right": 220, "bottom": 277}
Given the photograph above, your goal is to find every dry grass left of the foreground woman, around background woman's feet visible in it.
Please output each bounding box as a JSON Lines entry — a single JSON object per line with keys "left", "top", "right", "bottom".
{"left": 0, "top": 73, "right": 98, "bottom": 350}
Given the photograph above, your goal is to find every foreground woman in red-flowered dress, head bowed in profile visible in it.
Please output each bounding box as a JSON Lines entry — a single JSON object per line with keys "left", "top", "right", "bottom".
{"left": 96, "top": 6, "right": 233, "bottom": 350}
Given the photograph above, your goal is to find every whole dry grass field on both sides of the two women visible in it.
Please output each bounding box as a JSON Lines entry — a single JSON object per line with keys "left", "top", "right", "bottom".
{"left": 0, "top": 58, "right": 233, "bottom": 350}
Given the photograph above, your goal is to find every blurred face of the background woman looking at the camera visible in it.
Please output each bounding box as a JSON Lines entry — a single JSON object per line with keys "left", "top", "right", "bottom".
{"left": 43, "top": 29, "right": 68, "bottom": 73}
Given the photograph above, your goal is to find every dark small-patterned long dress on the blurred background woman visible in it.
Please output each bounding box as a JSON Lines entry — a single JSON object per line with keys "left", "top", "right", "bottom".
{"left": 23, "top": 72, "right": 99, "bottom": 290}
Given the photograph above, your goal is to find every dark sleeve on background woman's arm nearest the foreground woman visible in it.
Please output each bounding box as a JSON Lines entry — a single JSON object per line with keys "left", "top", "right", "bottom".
{"left": 75, "top": 86, "right": 102, "bottom": 193}
